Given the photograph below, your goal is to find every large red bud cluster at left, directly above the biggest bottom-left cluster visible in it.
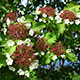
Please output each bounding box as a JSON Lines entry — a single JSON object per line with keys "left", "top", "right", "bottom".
{"left": 7, "top": 23, "right": 29, "bottom": 39}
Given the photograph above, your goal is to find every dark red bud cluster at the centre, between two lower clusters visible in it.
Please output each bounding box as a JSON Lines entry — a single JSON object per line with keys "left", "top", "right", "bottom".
{"left": 35, "top": 38, "right": 48, "bottom": 52}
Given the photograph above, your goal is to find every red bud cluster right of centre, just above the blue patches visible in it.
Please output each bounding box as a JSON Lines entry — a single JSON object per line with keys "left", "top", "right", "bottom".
{"left": 51, "top": 43, "right": 66, "bottom": 56}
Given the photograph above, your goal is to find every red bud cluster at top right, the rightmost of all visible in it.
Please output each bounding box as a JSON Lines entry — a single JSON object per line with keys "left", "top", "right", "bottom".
{"left": 60, "top": 10, "right": 76, "bottom": 21}
